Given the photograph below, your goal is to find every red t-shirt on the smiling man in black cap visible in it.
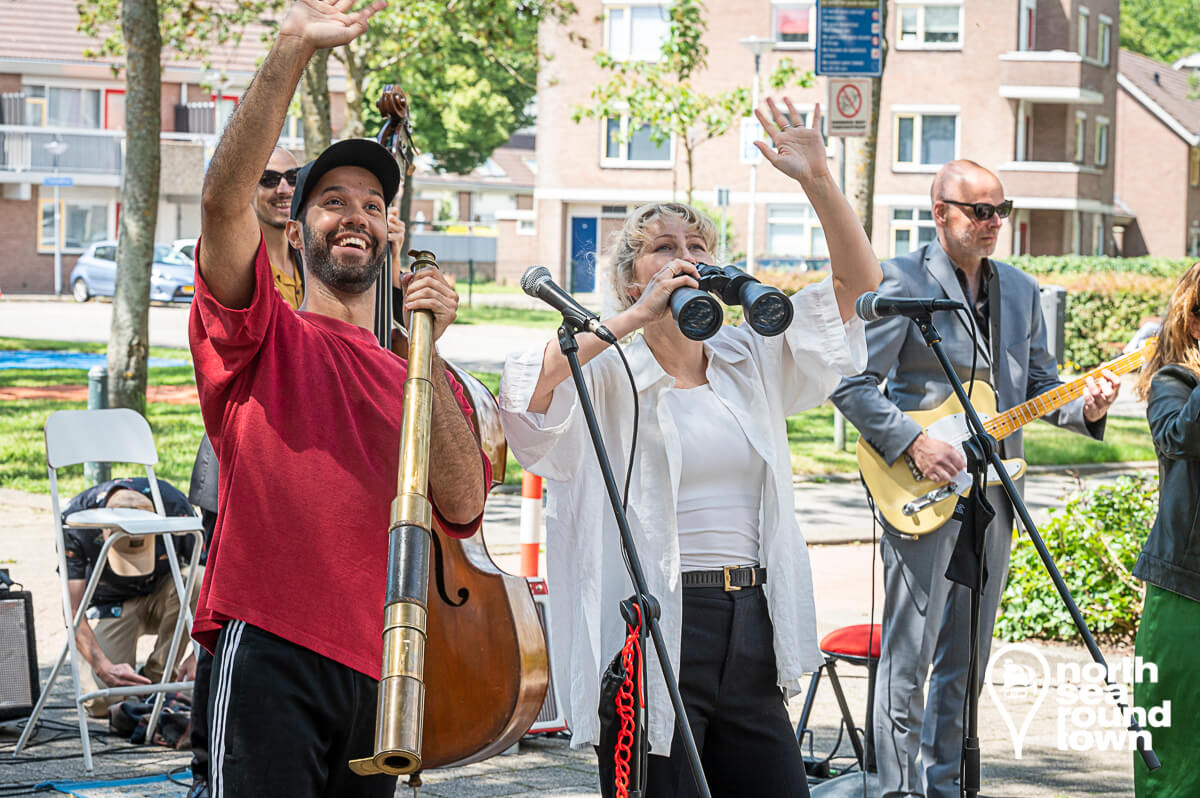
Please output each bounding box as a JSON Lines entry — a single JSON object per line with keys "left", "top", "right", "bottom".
{"left": 188, "top": 237, "right": 491, "bottom": 679}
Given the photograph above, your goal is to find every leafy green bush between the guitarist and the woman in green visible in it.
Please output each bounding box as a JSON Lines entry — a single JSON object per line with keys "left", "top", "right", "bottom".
{"left": 996, "top": 474, "right": 1158, "bottom": 641}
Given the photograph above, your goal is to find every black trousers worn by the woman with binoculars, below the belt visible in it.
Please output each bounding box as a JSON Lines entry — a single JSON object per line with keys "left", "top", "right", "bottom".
{"left": 600, "top": 587, "right": 809, "bottom": 798}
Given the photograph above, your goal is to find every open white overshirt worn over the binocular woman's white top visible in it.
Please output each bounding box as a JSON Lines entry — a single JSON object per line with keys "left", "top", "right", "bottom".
{"left": 499, "top": 278, "right": 866, "bottom": 756}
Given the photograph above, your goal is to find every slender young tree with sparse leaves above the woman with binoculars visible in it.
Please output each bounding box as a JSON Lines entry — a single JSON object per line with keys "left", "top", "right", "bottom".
{"left": 571, "top": 0, "right": 812, "bottom": 203}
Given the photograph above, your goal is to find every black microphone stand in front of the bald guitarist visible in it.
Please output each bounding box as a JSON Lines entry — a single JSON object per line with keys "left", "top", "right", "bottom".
{"left": 912, "top": 311, "right": 1159, "bottom": 798}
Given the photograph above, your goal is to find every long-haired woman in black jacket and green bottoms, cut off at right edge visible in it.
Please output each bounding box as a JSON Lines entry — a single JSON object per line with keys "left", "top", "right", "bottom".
{"left": 1133, "top": 263, "right": 1200, "bottom": 798}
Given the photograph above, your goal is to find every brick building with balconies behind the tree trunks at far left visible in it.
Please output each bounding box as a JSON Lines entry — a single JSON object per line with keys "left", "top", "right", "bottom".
{"left": 0, "top": 0, "right": 344, "bottom": 293}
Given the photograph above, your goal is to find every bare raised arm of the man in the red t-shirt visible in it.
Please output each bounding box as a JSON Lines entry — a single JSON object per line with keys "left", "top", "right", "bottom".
{"left": 197, "top": 0, "right": 385, "bottom": 308}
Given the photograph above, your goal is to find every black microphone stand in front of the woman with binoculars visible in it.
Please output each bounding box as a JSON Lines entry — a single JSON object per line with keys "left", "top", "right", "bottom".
{"left": 558, "top": 317, "right": 712, "bottom": 798}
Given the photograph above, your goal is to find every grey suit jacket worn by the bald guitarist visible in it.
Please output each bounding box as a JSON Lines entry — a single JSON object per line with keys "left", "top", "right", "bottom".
{"left": 830, "top": 239, "right": 1104, "bottom": 463}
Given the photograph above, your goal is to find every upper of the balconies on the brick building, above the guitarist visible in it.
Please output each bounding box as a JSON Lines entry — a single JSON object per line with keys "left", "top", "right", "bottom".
{"left": 1000, "top": 50, "right": 1116, "bottom": 106}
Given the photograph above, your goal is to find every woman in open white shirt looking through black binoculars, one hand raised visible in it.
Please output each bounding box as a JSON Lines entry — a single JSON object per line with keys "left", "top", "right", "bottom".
{"left": 500, "top": 100, "right": 882, "bottom": 798}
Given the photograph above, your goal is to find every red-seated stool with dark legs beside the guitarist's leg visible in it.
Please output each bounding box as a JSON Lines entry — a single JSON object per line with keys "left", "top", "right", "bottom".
{"left": 796, "top": 624, "right": 882, "bottom": 773}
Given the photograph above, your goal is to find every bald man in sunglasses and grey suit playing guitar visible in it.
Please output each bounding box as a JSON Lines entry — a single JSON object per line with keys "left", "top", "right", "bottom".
{"left": 832, "top": 161, "right": 1120, "bottom": 798}
